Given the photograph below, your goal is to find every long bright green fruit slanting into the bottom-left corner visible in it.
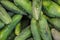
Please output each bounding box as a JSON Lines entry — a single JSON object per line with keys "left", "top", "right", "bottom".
{"left": 0, "top": 15, "right": 22, "bottom": 40}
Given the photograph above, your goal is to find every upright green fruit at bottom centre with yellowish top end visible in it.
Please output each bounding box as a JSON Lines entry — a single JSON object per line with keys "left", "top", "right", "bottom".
{"left": 31, "top": 19, "right": 41, "bottom": 40}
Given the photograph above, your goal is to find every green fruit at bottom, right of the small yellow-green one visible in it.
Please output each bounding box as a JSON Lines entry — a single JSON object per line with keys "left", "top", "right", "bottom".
{"left": 14, "top": 27, "right": 31, "bottom": 40}
